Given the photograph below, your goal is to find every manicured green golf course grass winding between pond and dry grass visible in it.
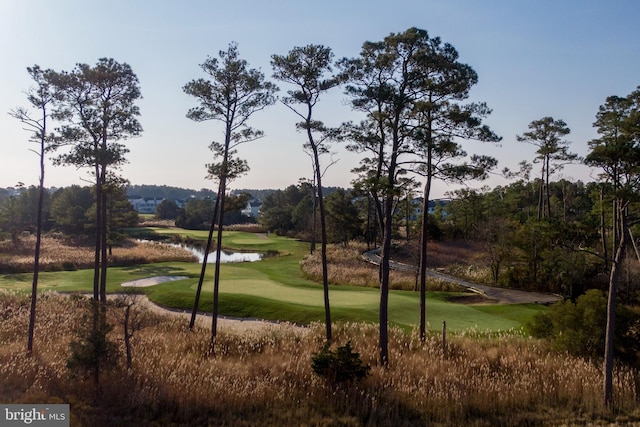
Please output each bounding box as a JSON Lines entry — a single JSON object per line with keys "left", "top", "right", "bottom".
{"left": 0, "top": 228, "right": 543, "bottom": 331}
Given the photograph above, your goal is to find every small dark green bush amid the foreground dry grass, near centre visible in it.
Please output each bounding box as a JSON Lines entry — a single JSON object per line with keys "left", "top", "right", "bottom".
{"left": 311, "top": 341, "right": 371, "bottom": 384}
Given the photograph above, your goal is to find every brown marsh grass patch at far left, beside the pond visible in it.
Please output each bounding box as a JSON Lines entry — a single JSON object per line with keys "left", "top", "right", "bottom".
{"left": 0, "top": 236, "right": 197, "bottom": 273}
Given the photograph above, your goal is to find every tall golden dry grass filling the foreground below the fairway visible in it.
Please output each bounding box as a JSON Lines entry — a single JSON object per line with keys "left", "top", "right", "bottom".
{"left": 0, "top": 293, "right": 640, "bottom": 426}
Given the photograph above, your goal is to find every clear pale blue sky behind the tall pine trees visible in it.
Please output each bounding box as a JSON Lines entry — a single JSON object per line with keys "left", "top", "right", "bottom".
{"left": 0, "top": 0, "right": 640, "bottom": 197}
